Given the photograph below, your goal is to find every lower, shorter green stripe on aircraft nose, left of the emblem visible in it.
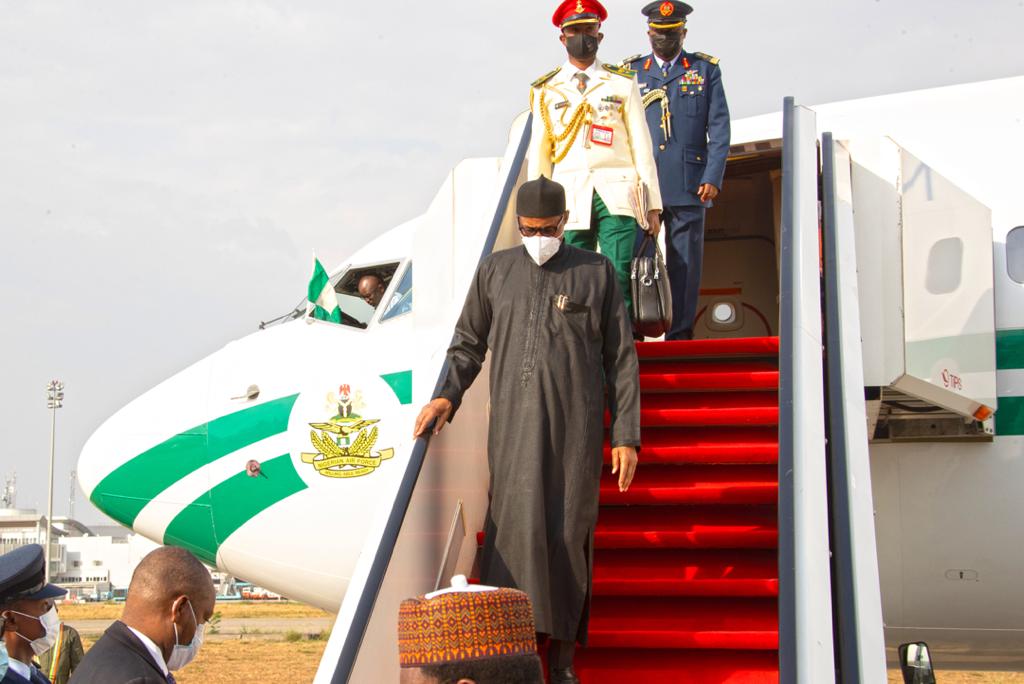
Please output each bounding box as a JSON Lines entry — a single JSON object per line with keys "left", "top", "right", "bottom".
{"left": 164, "top": 454, "right": 306, "bottom": 565}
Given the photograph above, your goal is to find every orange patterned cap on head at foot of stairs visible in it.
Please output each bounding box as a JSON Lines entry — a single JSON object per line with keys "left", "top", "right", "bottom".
{"left": 398, "top": 576, "right": 537, "bottom": 668}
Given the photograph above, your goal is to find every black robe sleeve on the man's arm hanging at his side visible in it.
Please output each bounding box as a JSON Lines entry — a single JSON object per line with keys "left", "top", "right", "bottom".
{"left": 601, "top": 262, "right": 640, "bottom": 450}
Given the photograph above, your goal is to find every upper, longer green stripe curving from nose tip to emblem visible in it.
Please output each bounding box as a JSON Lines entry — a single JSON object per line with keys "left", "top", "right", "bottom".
{"left": 89, "top": 394, "right": 299, "bottom": 527}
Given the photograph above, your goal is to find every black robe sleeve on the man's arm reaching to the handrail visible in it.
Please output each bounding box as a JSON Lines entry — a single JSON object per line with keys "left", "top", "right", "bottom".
{"left": 437, "top": 261, "right": 490, "bottom": 413}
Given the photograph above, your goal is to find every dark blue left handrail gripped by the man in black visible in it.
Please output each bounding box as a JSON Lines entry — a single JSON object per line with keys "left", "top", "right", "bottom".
{"left": 323, "top": 115, "right": 532, "bottom": 684}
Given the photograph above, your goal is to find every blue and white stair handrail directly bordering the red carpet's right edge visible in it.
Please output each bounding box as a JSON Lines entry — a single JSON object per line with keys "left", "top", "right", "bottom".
{"left": 778, "top": 97, "right": 836, "bottom": 684}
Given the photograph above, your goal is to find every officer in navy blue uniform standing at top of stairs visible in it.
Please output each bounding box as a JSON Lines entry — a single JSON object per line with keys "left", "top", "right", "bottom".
{"left": 624, "top": 0, "right": 729, "bottom": 340}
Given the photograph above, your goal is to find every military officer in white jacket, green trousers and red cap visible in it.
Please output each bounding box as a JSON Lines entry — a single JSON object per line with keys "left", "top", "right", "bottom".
{"left": 528, "top": 0, "right": 662, "bottom": 312}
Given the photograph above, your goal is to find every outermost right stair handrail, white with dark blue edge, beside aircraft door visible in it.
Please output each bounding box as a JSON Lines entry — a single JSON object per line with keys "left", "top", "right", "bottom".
{"left": 821, "top": 133, "right": 887, "bottom": 684}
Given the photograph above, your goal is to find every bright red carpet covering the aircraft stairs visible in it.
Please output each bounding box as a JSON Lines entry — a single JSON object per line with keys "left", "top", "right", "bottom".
{"left": 575, "top": 338, "right": 778, "bottom": 684}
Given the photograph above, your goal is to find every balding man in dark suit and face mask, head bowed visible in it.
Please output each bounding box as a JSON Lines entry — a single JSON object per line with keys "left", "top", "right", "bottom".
{"left": 71, "top": 547, "right": 216, "bottom": 684}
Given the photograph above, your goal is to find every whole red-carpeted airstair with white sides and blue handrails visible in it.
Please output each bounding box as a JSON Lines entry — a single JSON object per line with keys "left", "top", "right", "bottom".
{"left": 316, "top": 98, "right": 886, "bottom": 684}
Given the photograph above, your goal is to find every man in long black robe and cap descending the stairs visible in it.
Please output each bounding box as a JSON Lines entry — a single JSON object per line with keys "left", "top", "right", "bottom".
{"left": 415, "top": 176, "right": 640, "bottom": 682}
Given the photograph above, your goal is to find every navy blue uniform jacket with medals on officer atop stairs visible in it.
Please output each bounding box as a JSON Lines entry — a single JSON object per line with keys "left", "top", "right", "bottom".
{"left": 628, "top": 51, "right": 730, "bottom": 207}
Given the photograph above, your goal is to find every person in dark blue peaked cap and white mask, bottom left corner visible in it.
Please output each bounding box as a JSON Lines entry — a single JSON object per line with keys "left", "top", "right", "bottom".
{"left": 0, "top": 544, "right": 68, "bottom": 684}
